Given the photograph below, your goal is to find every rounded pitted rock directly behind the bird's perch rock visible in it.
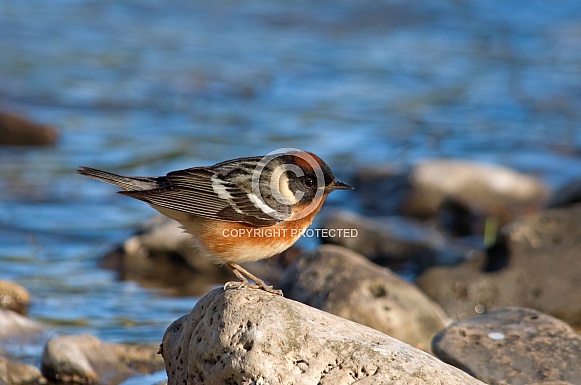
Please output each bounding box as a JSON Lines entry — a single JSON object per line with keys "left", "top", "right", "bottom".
{"left": 279, "top": 245, "right": 447, "bottom": 350}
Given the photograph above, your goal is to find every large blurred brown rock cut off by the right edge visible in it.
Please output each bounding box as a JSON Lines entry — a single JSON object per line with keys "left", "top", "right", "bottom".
{"left": 417, "top": 206, "right": 581, "bottom": 326}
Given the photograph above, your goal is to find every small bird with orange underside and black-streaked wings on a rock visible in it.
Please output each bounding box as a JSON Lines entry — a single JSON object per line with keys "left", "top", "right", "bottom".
{"left": 77, "top": 149, "right": 353, "bottom": 295}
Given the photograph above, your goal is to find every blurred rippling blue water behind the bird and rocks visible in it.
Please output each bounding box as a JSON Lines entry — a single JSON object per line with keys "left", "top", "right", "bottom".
{"left": 0, "top": 0, "right": 581, "bottom": 376}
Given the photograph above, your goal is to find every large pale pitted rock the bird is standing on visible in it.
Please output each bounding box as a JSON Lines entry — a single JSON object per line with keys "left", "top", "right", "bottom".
{"left": 162, "top": 288, "right": 482, "bottom": 385}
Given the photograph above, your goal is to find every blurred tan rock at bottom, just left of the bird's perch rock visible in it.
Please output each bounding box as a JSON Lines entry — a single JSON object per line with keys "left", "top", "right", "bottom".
{"left": 41, "top": 335, "right": 163, "bottom": 384}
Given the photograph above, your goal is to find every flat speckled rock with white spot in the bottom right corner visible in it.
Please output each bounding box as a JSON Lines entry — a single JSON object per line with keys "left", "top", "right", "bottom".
{"left": 433, "top": 307, "right": 581, "bottom": 385}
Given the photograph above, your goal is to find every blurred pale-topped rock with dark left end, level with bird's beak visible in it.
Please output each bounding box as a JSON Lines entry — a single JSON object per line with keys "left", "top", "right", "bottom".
{"left": 353, "top": 159, "right": 548, "bottom": 224}
